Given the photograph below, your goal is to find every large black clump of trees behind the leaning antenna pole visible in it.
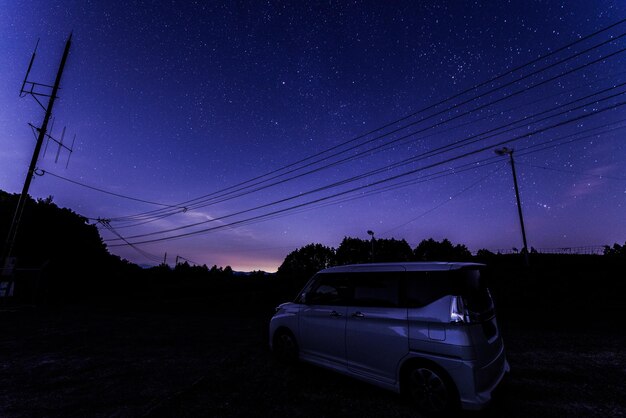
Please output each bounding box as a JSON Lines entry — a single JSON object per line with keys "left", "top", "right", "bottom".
{"left": 0, "top": 191, "right": 141, "bottom": 304}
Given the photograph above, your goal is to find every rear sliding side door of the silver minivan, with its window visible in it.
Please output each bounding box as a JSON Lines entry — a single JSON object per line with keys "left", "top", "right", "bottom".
{"left": 346, "top": 272, "right": 409, "bottom": 383}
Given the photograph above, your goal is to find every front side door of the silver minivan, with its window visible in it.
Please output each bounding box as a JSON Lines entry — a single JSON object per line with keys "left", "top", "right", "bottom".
{"left": 299, "top": 273, "right": 351, "bottom": 367}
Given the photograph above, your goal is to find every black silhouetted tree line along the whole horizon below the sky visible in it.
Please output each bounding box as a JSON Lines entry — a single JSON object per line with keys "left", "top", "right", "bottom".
{"left": 0, "top": 190, "right": 626, "bottom": 290}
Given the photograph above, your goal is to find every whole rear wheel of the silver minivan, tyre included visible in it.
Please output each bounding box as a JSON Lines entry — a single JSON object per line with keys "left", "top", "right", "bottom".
{"left": 405, "top": 365, "right": 458, "bottom": 416}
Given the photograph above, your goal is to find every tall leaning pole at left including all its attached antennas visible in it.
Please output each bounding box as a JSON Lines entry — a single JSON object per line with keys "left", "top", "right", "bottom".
{"left": 2, "top": 33, "right": 72, "bottom": 276}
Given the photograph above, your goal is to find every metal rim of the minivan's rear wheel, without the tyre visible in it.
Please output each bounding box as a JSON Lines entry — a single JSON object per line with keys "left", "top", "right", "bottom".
{"left": 409, "top": 368, "right": 450, "bottom": 413}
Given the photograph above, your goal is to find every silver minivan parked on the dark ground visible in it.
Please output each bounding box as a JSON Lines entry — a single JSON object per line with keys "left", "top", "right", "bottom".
{"left": 270, "top": 262, "right": 509, "bottom": 415}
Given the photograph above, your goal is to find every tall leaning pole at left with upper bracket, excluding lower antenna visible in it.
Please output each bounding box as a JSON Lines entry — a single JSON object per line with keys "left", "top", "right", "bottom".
{"left": 2, "top": 33, "right": 72, "bottom": 275}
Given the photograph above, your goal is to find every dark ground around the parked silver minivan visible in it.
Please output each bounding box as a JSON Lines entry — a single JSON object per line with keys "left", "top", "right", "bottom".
{"left": 0, "top": 266, "right": 626, "bottom": 418}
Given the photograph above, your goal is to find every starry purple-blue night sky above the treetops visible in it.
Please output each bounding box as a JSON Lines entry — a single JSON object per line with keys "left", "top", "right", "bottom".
{"left": 0, "top": 0, "right": 626, "bottom": 271}
